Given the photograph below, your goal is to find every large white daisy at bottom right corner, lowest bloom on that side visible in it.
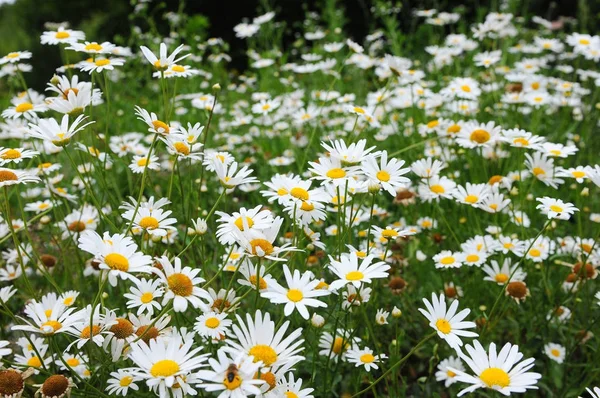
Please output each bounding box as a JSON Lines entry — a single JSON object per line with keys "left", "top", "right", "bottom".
{"left": 449, "top": 340, "right": 542, "bottom": 397}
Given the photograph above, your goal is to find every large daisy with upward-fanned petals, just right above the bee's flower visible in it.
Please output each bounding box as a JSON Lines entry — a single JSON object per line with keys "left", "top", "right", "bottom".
{"left": 225, "top": 310, "right": 304, "bottom": 368}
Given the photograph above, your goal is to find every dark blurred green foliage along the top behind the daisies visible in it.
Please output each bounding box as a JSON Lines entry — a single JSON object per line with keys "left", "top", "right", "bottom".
{"left": 0, "top": 0, "right": 600, "bottom": 87}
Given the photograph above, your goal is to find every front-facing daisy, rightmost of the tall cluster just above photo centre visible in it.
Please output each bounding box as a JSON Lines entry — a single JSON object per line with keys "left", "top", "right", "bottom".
{"left": 363, "top": 151, "right": 410, "bottom": 197}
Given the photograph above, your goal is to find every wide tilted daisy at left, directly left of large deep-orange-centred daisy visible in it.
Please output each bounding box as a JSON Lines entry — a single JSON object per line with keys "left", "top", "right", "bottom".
{"left": 78, "top": 230, "right": 152, "bottom": 286}
